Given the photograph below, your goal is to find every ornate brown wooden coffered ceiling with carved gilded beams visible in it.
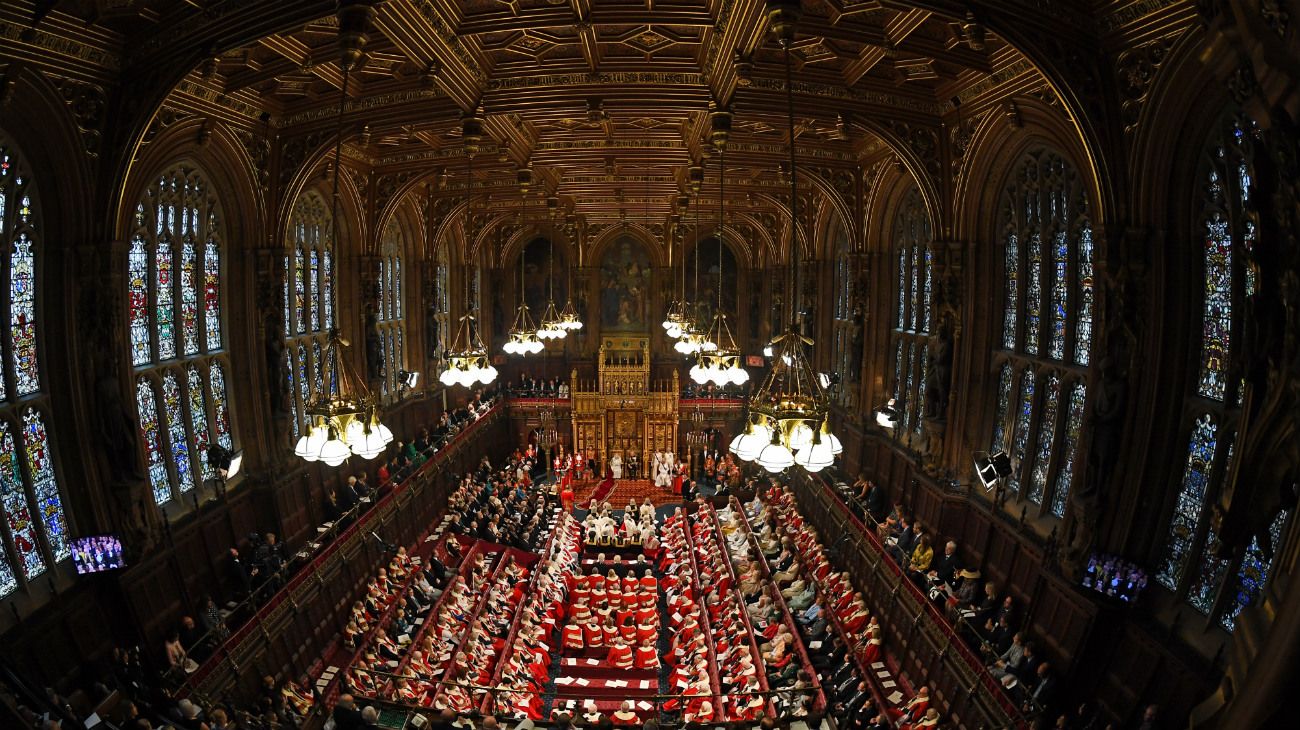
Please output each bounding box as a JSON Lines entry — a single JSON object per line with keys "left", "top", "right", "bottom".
{"left": 12, "top": 0, "right": 1086, "bottom": 251}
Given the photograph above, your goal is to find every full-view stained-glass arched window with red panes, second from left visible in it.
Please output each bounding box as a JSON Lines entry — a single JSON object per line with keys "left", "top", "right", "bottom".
{"left": 126, "top": 164, "right": 234, "bottom": 504}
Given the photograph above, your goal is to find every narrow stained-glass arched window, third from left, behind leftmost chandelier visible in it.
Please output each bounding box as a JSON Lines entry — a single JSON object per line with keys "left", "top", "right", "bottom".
{"left": 285, "top": 192, "right": 334, "bottom": 443}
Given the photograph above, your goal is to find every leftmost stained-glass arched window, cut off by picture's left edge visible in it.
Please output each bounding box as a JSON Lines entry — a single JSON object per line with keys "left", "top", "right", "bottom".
{"left": 0, "top": 131, "right": 72, "bottom": 599}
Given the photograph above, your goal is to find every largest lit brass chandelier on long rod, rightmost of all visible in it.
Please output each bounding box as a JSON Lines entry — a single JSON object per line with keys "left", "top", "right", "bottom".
{"left": 728, "top": 0, "right": 842, "bottom": 473}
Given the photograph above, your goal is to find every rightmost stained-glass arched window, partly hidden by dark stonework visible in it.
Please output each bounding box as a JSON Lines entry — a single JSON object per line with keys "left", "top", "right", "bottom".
{"left": 1156, "top": 113, "right": 1290, "bottom": 631}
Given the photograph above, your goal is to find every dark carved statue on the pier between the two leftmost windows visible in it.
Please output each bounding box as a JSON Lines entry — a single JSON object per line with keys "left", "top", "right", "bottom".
{"left": 78, "top": 277, "right": 163, "bottom": 559}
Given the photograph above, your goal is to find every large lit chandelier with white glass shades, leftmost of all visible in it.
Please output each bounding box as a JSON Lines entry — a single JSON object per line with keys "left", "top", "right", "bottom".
{"left": 294, "top": 21, "right": 393, "bottom": 466}
